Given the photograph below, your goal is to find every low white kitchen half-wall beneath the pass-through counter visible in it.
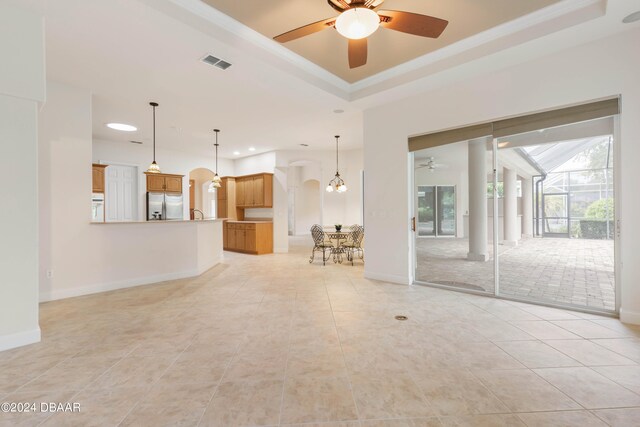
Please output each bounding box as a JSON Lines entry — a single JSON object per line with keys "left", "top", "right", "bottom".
{"left": 41, "top": 219, "right": 223, "bottom": 301}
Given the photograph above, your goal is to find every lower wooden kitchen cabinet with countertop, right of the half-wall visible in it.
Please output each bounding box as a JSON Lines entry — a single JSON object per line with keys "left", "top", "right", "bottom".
{"left": 223, "top": 221, "right": 273, "bottom": 255}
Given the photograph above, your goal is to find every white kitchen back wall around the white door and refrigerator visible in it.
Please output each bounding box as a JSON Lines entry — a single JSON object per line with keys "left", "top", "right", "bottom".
{"left": 92, "top": 139, "right": 234, "bottom": 220}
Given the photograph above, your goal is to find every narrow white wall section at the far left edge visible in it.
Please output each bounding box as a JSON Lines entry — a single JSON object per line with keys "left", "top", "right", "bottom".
{"left": 0, "top": 3, "right": 45, "bottom": 351}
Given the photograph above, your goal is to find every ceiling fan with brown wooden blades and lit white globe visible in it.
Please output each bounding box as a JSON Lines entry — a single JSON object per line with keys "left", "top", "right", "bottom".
{"left": 273, "top": 0, "right": 449, "bottom": 68}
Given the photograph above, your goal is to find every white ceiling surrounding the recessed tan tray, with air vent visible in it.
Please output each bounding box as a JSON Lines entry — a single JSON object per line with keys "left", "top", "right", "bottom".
{"left": 20, "top": 0, "right": 640, "bottom": 158}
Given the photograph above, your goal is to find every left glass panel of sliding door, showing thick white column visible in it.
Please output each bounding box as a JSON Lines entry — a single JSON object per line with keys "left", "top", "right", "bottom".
{"left": 414, "top": 139, "right": 495, "bottom": 294}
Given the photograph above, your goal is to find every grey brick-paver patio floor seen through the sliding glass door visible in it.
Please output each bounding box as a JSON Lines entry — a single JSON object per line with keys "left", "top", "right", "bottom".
{"left": 417, "top": 238, "right": 615, "bottom": 310}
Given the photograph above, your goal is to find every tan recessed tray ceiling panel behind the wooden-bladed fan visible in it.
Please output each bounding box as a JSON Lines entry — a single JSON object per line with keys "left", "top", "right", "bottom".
{"left": 202, "top": 0, "right": 560, "bottom": 83}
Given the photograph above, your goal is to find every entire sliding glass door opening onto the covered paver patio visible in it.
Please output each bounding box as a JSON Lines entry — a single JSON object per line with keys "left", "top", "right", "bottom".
{"left": 413, "top": 105, "right": 618, "bottom": 312}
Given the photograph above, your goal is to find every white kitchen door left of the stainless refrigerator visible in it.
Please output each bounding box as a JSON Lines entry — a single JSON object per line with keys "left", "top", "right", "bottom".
{"left": 105, "top": 164, "right": 138, "bottom": 222}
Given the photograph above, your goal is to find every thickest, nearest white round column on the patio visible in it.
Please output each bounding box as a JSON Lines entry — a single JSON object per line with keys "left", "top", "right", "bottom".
{"left": 467, "top": 139, "right": 489, "bottom": 261}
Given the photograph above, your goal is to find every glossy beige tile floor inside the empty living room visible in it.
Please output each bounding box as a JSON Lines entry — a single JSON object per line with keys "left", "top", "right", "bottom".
{"left": 0, "top": 239, "right": 640, "bottom": 427}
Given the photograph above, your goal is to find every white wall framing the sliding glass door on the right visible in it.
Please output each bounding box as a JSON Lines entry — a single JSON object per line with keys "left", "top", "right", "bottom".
{"left": 364, "top": 29, "right": 640, "bottom": 323}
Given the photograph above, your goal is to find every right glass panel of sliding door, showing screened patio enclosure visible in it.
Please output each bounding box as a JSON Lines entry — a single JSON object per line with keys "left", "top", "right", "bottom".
{"left": 498, "top": 118, "right": 616, "bottom": 311}
